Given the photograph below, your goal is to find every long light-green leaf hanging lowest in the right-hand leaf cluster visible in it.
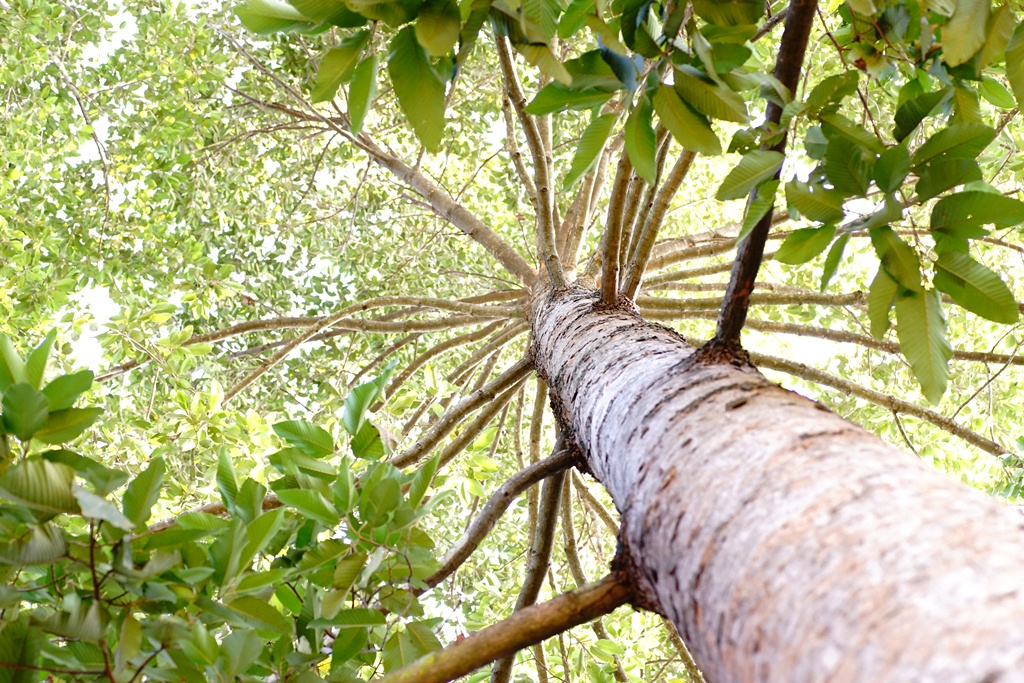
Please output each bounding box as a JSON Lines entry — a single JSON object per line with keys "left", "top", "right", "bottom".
{"left": 896, "top": 290, "right": 952, "bottom": 403}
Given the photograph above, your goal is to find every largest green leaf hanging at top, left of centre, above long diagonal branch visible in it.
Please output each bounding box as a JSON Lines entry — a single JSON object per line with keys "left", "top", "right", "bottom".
{"left": 387, "top": 27, "right": 444, "bottom": 152}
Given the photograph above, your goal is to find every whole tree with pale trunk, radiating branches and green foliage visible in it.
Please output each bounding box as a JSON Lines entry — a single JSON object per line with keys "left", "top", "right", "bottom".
{"left": 0, "top": 0, "right": 1024, "bottom": 681}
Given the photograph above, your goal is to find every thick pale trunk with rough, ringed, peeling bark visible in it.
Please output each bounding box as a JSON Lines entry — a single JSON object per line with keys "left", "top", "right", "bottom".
{"left": 532, "top": 289, "right": 1024, "bottom": 683}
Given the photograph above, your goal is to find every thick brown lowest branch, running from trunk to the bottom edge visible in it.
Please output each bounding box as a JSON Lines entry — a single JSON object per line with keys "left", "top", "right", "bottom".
{"left": 377, "top": 574, "right": 632, "bottom": 683}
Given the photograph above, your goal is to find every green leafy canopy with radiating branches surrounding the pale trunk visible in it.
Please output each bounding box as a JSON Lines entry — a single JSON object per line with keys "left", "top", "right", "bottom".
{"left": 6, "top": 0, "right": 1024, "bottom": 683}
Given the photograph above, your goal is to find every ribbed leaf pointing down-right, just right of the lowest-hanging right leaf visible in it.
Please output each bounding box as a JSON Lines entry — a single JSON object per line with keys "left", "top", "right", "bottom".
{"left": 934, "top": 251, "right": 1020, "bottom": 325}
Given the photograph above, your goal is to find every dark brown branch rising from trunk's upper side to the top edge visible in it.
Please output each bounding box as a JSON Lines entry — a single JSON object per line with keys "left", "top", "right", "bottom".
{"left": 711, "top": 0, "right": 818, "bottom": 348}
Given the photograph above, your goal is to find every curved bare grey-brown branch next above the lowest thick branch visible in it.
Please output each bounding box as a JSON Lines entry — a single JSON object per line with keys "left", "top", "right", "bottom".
{"left": 424, "top": 451, "right": 572, "bottom": 588}
